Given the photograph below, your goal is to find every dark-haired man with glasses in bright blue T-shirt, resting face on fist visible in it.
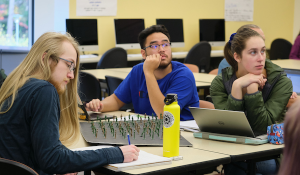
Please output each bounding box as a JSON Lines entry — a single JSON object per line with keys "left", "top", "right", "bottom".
{"left": 87, "top": 25, "right": 199, "bottom": 120}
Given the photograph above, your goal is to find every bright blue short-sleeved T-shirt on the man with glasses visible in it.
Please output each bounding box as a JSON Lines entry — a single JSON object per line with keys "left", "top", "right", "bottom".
{"left": 114, "top": 61, "right": 199, "bottom": 120}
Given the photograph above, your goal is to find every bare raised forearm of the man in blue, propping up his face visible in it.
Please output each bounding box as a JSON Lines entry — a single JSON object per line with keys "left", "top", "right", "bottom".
{"left": 145, "top": 73, "right": 165, "bottom": 117}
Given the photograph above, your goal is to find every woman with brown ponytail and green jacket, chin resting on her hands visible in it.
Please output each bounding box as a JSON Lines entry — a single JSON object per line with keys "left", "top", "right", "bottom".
{"left": 210, "top": 28, "right": 293, "bottom": 174}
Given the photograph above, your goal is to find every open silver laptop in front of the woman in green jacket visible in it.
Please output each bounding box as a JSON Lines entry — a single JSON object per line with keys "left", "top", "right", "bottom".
{"left": 190, "top": 107, "right": 267, "bottom": 138}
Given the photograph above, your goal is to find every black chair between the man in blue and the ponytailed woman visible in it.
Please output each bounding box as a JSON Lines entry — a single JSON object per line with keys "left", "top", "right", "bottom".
{"left": 184, "top": 41, "right": 211, "bottom": 73}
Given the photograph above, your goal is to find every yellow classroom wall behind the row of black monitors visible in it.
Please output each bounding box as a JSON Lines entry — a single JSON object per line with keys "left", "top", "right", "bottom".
{"left": 69, "top": 0, "right": 295, "bottom": 54}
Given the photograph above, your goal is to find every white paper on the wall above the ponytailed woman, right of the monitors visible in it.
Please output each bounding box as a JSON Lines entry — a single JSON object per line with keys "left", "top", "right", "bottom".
{"left": 225, "top": 0, "right": 254, "bottom": 21}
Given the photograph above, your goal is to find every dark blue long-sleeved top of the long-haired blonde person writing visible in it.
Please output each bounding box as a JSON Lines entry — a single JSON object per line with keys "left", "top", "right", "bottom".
{"left": 0, "top": 79, "right": 124, "bottom": 174}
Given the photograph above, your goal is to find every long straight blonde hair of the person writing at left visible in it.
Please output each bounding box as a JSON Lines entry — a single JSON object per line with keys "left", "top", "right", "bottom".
{"left": 0, "top": 32, "right": 80, "bottom": 146}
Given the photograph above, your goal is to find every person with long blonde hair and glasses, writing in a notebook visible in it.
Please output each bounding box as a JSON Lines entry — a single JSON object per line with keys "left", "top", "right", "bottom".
{"left": 0, "top": 32, "right": 139, "bottom": 174}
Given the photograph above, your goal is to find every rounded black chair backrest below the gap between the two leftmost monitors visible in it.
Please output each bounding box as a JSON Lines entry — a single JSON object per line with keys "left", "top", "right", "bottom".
{"left": 97, "top": 47, "right": 127, "bottom": 69}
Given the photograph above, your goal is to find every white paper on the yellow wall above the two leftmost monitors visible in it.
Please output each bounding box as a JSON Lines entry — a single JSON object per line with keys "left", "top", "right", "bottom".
{"left": 76, "top": 0, "right": 117, "bottom": 16}
